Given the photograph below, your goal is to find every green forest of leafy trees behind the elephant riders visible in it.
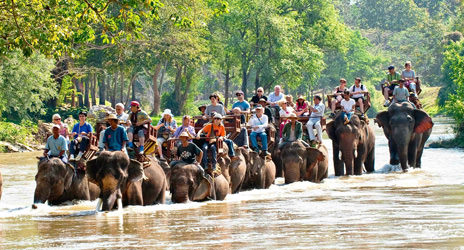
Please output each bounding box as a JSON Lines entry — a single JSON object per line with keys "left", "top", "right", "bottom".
{"left": 0, "top": 0, "right": 464, "bottom": 146}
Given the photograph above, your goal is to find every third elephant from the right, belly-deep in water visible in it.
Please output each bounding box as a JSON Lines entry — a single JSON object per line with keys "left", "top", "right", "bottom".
{"left": 281, "top": 140, "right": 328, "bottom": 184}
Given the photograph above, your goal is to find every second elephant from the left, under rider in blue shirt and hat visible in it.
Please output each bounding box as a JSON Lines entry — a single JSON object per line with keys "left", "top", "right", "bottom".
{"left": 86, "top": 151, "right": 167, "bottom": 211}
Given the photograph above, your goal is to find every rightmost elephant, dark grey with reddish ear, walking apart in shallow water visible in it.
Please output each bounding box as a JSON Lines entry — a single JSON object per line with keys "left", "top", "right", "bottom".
{"left": 375, "top": 102, "right": 433, "bottom": 172}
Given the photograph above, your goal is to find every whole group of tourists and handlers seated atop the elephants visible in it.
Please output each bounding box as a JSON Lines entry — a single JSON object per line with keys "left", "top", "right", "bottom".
{"left": 44, "top": 62, "right": 417, "bottom": 175}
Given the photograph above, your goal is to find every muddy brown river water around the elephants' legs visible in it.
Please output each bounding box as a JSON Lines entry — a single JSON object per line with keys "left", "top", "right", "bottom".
{"left": 0, "top": 118, "right": 464, "bottom": 249}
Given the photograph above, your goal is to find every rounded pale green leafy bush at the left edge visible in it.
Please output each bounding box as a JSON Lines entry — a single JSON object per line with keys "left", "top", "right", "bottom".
{"left": 0, "top": 51, "right": 56, "bottom": 120}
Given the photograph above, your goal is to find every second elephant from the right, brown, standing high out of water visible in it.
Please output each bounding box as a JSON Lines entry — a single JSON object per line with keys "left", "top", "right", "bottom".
{"left": 326, "top": 113, "right": 375, "bottom": 176}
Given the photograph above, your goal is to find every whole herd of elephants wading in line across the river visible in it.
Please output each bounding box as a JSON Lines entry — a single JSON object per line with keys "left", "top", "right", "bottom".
{"left": 0, "top": 102, "right": 433, "bottom": 211}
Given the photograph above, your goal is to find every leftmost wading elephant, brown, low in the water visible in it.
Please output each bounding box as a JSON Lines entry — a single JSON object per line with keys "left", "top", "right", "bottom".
{"left": 33, "top": 158, "right": 100, "bottom": 208}
